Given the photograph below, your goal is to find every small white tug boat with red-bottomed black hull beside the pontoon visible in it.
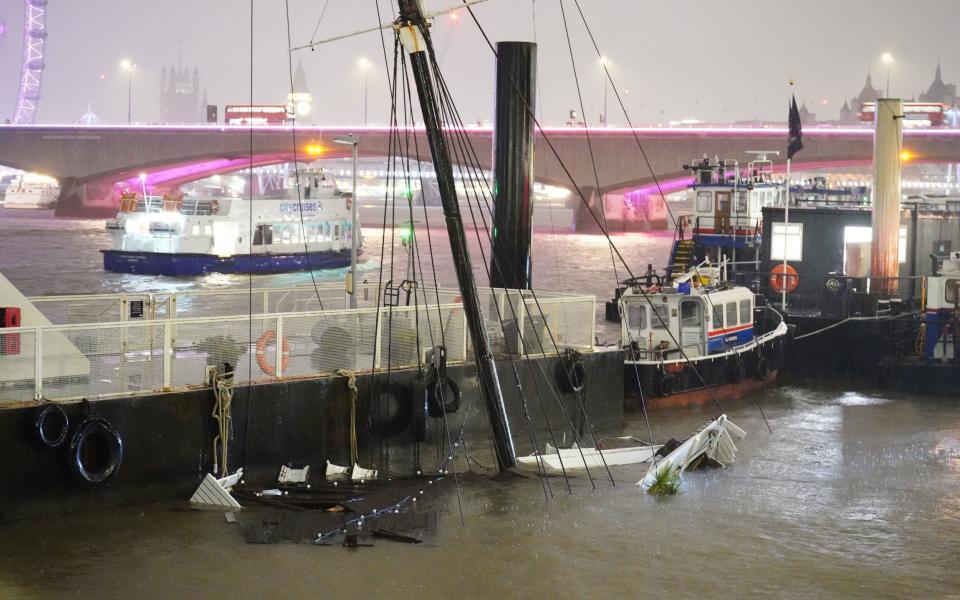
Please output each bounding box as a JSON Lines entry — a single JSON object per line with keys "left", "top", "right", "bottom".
{"left": 618, "top": 262, "right": 788, "bottom": 407}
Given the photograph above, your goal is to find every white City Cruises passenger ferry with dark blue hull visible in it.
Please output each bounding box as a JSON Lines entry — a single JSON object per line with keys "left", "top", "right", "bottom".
{"left": 103, "top": 175, "right": 362, "bottom": 276}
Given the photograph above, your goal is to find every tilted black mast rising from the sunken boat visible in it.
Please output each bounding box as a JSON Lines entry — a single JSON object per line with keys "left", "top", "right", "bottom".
{"left": 395, "top": 0, "right": 517, "bottom": 471}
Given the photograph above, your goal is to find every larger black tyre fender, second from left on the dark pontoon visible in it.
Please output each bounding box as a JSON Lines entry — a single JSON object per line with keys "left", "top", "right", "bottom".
{"left": 68, "top": 418, "right": 123, "bottom": 487}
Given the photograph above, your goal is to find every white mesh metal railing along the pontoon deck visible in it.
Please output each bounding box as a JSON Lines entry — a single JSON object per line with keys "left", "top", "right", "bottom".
{"left": 0, "top": 286, "right": 595, "bottom": 403}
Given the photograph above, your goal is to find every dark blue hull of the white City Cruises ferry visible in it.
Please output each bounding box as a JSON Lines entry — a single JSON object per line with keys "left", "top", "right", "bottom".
{"left": 102, "top": 250, "right": 350, "bottom": 277}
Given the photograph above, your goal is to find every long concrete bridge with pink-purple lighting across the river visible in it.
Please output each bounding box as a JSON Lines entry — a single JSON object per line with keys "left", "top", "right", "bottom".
{"left": 0, "top": 125, "right": 960, "bottom": 223}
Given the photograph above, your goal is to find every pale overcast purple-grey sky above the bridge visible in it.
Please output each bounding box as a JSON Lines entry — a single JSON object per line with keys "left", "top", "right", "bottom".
{"left": 0, "top": 0, "right": 960, "bottom": 123}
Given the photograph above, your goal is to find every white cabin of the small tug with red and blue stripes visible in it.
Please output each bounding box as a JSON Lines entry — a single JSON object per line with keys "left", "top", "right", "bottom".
{"left": 620, "top": 282, "right": 754, "bottom": 361}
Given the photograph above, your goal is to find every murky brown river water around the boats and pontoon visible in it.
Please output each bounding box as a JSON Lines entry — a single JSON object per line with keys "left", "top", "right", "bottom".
{"left": 0, "top": 213, "right": 960, "bottom": 598}
